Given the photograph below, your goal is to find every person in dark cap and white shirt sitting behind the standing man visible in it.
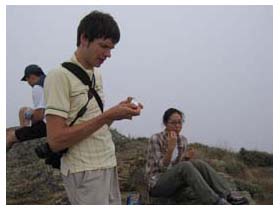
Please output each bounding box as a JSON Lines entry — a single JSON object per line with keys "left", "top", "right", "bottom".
{"left": 6, "top": 64, "right": 46, "bottom": 151}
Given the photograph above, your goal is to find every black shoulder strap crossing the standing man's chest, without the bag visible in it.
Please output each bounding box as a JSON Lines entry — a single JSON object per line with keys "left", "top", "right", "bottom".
{"left": 61, "top": 62, "right": 103, "bottom": 126}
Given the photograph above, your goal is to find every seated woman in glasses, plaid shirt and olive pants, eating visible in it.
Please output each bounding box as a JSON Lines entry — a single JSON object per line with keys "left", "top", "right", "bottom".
{"left": 146, "top": 108, "right": 248, "bottom": 205}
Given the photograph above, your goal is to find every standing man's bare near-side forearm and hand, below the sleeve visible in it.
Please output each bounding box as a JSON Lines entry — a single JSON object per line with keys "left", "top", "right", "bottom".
{"left": 46, "top": 97, "right": 142, "bottom": 152}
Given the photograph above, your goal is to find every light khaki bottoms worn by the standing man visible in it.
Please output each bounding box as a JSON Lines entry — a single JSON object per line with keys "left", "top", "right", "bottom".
{"left": 62, "top": 167, "right": 121, "bottom": 205}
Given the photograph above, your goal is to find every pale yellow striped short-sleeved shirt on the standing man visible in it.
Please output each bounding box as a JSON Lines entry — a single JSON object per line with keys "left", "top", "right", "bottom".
{"left": 44, "top": 55, "right": 117, "bottom": 176}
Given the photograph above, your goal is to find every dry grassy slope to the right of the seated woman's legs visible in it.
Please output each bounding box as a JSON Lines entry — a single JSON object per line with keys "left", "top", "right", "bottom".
{"left": 190, "top": 144, "right": 273, "bottom": 204}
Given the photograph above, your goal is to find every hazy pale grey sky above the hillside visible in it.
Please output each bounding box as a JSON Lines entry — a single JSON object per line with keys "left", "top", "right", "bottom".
{"left": 6, "top": 6, "right": 273, "bottom": 152}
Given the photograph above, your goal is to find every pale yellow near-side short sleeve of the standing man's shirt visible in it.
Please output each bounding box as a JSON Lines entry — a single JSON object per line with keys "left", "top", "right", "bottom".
{"left": 44, "top": 69, "right": 70, "bottom": 119}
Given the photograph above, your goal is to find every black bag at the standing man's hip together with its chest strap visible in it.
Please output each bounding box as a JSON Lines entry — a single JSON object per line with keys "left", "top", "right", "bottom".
{"left": 35, "top": 62, "right": 104, "bottom": 169}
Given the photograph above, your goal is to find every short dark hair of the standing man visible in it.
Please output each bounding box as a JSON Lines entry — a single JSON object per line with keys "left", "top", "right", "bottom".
{"left": 77, "top": 10, "right": 120, "bottom": 47}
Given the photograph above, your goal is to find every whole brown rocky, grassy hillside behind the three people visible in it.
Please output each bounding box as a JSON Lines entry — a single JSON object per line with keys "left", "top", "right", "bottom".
{"left": 6, "top": 130, "right": 273, "bottom": 204}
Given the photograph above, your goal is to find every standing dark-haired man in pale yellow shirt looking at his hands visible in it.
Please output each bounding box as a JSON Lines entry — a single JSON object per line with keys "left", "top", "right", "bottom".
{"left": 45, "top": 11, "right": 142, "bottom": 204}
